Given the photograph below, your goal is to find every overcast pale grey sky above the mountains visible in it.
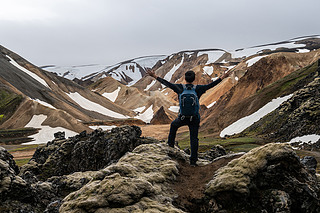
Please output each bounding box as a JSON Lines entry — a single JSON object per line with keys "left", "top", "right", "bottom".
{"left": 0, "top": 0, "right": 320, "bottom": 66}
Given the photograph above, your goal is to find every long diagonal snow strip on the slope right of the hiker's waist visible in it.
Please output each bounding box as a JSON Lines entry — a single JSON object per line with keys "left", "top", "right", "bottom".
{"left": 220, "top": 94, "right": 292, "bottom": 137}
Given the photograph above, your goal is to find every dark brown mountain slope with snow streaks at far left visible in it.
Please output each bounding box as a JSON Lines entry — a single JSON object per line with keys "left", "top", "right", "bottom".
{"left": 0, "top": 46, "right": 134, "bottom": 143}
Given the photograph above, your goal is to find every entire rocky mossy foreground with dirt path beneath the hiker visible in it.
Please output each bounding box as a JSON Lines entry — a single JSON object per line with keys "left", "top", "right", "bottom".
{"left": 0, "top": 126, "right": 320, "bottom": 213}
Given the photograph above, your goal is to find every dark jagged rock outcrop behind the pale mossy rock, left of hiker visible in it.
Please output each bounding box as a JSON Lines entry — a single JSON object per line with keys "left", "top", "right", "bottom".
{"left": 20, "top": 126, "right": 150, "bottom": 181}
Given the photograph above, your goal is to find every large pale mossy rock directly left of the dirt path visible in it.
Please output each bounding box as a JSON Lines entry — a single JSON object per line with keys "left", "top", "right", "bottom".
{"left": 60, "top": 144, "right": 187, "bottom": 213}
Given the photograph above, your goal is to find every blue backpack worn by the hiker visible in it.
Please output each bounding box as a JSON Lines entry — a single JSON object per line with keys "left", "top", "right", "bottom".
{"left": 179, "top": 84, "right": 200, "bottom": 120}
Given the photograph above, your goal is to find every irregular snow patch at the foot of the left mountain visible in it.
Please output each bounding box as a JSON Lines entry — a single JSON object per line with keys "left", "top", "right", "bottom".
{"left": 23, "top": 115, "right": 78, "bottom": 145}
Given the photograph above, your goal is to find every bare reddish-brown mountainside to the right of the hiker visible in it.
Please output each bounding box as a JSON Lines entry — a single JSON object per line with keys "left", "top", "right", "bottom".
{"left": 202, "top": 50, "right": 320, "bottom": 134}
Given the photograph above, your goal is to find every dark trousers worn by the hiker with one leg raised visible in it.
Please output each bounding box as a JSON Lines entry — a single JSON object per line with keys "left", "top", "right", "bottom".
{"left": 168, "top": 116, "right": 200, "bottom": 162}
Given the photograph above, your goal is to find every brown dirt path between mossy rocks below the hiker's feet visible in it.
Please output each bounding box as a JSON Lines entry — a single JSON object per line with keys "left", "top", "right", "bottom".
{"left": 171, "top": 155, "right": 240, "bottom": 212}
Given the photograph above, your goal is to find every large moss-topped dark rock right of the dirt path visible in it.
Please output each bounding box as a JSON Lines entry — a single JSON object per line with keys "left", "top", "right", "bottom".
{"left": 205, "top": 143, "right": 320, "bottom": 212}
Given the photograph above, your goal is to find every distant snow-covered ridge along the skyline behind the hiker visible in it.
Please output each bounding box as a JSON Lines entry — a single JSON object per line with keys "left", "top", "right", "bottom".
{"left": 44, "top": 35, "right": 320, "bottom": 90}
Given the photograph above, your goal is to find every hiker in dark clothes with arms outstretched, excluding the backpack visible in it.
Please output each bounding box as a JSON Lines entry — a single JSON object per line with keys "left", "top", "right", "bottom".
{"left": 146, "top": 68, "right": 229, "bottom": 166}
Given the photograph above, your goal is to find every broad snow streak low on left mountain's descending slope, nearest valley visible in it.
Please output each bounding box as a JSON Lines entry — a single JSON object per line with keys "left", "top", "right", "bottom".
{"left": 66, "top": 92, "right": 127, "bottom": 119}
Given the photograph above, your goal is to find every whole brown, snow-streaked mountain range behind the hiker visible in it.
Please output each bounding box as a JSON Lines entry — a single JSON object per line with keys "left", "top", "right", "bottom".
{"left": 0, "top": 35, "right": 320, "bottom": 145}
